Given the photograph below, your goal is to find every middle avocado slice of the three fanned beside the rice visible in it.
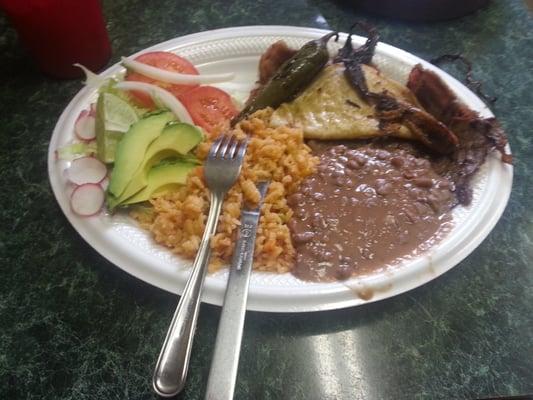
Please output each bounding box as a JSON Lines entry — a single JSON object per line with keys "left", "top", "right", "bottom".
{"left": 117, "top": 122, "right": 203, "bottom": 204}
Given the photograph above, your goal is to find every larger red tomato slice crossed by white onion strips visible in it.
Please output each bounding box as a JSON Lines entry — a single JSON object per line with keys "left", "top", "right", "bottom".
{"left": 125, "top": 51, "right": 198, "bottom": 109}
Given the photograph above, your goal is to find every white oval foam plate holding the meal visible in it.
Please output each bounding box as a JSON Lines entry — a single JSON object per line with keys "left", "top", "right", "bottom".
{"left": 48, "top": 26, "right": 513, "bottom": 312}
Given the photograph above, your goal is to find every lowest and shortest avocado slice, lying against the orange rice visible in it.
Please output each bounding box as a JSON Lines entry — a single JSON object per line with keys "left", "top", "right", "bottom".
{"left": 122, "top": 161, "right": 197, "bottom": 205}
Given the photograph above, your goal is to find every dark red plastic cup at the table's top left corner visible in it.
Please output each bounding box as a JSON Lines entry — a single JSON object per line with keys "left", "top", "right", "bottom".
{"left": 0, "top": 0, "right": 111, "bottom": 78}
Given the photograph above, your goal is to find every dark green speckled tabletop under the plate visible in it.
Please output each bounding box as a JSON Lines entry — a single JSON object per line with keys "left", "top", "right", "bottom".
{"left": 0, "top": 0, "right": 533, "bottom": 400}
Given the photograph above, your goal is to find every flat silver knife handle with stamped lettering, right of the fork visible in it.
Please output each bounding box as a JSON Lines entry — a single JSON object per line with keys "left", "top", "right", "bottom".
{"left": 205, "top": 211, "right": 259, "bottom": 400}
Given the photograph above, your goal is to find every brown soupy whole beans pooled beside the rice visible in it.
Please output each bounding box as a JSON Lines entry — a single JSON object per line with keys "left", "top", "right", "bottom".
{"left": 288, "top": 144, "right": 455, "bottom": 281}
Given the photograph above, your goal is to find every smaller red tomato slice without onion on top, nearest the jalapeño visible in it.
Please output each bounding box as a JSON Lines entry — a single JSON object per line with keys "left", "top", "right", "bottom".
{"left": 179, "top": 86, "right": 238, "bottom": 133}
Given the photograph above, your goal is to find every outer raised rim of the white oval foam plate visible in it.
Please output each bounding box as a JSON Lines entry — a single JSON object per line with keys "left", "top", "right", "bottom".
{"left": 48, "top": 25, "right": 513, "bottom": 313}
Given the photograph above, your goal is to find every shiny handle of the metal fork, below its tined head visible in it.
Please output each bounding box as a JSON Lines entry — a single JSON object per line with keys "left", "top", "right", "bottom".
{"left": 153, "top": 193, "right": 224, "bottom": 397}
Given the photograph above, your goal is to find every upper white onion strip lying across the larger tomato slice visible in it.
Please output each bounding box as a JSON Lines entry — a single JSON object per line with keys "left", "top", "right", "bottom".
{"left": 122, "top": 57, "right": 235, "bottom": 85}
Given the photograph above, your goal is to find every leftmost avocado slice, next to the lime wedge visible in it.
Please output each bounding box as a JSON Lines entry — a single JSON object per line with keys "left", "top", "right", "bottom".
{"left": 107, "top": 111, "right": 175, "bottom": 200}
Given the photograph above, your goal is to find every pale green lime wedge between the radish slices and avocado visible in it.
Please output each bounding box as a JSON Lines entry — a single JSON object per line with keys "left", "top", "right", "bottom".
{"left": 96, "top": 93, "right": 139, "bottom": 163}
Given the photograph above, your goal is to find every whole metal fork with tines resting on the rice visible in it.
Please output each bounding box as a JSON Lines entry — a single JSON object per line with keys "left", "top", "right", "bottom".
{"left": 153, "top": 135, "right": 247, "bottom": 397}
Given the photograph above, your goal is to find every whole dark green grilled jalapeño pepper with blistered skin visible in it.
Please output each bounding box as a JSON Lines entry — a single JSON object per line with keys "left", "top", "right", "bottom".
{"left": 232, "top": 32, "right": 338, "bottom": 124}
